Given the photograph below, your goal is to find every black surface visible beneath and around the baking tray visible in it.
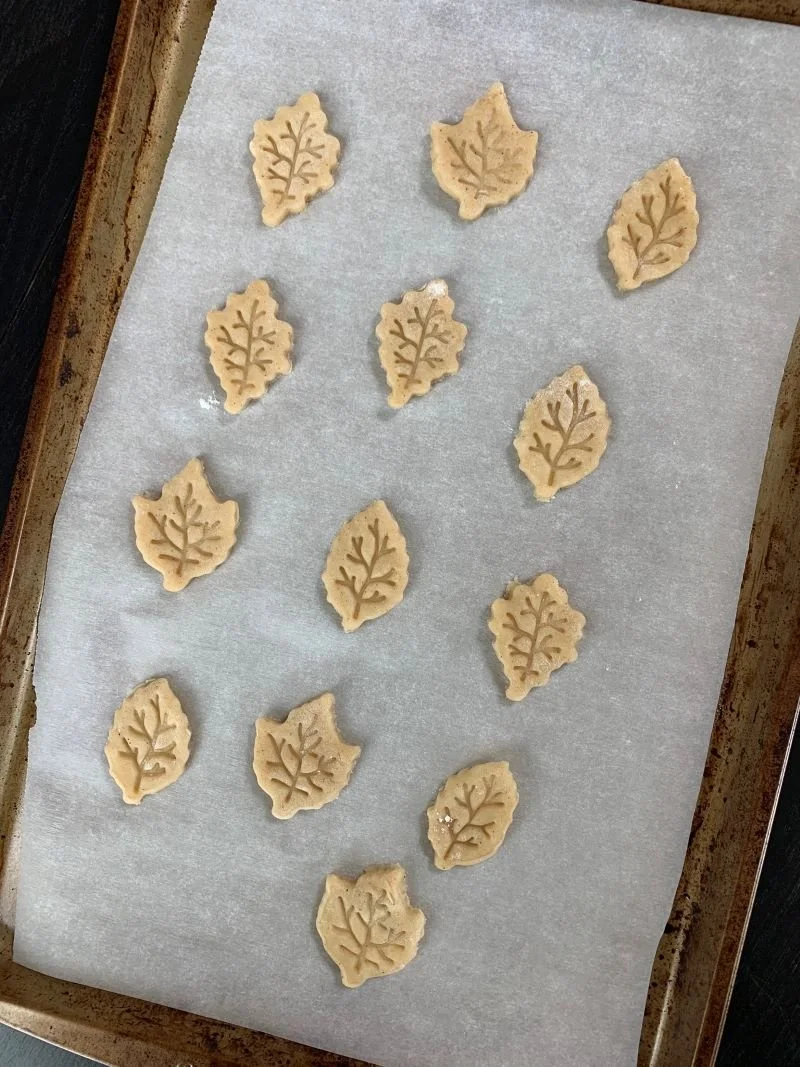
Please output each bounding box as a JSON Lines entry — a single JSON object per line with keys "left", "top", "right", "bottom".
{"left": 0, "top": 0, "right": 800, "bottom": 1067}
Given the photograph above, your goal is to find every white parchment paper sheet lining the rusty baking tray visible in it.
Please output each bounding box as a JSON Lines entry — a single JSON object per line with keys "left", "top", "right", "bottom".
{"left": 15, "top": 0, "right": 800, "bottom": 1067}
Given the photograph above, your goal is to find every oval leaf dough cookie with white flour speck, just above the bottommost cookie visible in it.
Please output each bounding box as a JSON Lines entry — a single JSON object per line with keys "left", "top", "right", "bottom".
{"left": 428, "top": 760, "right": 519, "bottom": 871}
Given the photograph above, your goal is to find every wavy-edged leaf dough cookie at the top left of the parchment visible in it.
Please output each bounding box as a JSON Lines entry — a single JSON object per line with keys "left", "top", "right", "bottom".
{"left": 250, "top": 93, "right": 339, "bottom": 226}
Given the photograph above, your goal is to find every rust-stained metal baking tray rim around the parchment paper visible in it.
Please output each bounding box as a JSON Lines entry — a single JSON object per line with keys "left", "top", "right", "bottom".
{"left": 0, "top": 0, "right": 800, "bottom": 1067}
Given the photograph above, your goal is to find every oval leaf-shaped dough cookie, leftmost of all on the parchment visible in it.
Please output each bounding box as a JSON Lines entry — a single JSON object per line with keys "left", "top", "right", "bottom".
{"left": 105, "top": 678, "right": 192, "bottom": 803}
